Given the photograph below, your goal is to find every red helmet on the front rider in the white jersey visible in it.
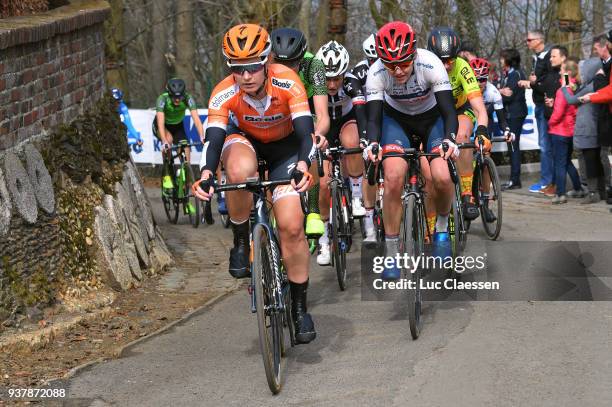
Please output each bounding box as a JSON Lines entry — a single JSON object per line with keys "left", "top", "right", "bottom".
{"left": 376, "top": 21, "right": 416, "bottom": 64}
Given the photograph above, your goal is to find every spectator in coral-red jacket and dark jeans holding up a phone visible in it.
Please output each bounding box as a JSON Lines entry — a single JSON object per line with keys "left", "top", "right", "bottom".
{"left": 548, "top": 59, "right": 582, "bottom": 204}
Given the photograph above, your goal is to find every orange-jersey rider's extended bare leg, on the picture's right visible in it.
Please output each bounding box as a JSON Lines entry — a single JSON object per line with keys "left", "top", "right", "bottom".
{"left": 274, "top": 194, "right": 310, "bottom": 283}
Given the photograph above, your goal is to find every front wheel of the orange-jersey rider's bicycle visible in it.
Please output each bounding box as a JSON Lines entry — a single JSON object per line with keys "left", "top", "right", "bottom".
{"left": 251, "top": 225, "right": 283, "bottom": 394}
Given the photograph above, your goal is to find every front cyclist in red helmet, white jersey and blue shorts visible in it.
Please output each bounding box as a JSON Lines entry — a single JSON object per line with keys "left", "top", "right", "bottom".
{"left": 366, "top": 21, "right": 459, "bottom": 280}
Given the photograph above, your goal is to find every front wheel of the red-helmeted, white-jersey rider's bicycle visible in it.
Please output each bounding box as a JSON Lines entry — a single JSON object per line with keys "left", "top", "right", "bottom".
{"left": 400, "top": 195, "right": 426, "bottom": 340}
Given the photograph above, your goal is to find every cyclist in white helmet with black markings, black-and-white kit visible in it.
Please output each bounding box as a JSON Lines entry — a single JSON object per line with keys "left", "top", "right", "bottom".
{"left": 316, "top": 41, "right": 374, "bottom": 265}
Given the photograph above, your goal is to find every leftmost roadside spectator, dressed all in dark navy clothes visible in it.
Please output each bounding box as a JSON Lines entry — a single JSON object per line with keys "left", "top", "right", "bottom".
{"left": 499, "top": 48, "right": 527, "bottom": 189}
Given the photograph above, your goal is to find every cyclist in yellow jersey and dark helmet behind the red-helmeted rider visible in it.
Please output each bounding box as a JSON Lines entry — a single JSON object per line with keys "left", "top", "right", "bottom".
{"left": 427, "top": 27, "right": 491, "bottom": 220}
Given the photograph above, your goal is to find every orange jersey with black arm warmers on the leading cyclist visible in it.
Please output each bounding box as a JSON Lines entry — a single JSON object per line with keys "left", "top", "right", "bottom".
{"left": 201, "top": 64, "right": 314, "bottom": 172}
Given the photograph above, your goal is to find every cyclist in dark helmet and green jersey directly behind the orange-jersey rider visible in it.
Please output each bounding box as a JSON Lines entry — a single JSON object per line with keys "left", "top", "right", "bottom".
{"left": 270, "top": 28, "right": 330, "bottom": 238}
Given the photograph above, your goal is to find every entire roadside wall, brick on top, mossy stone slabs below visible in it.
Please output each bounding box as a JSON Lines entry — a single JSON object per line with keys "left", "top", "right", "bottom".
{"left": 0, "top": 0, "right": 172, "bottom": 326}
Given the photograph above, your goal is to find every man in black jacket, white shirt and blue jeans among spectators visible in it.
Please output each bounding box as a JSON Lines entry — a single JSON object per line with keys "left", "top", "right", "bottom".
{"left": 519, "top": 30, "right": 554, "bottom": 192}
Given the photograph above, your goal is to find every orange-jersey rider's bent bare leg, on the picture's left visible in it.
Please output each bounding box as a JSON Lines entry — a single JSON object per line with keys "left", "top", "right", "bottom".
{"left": 221, "top": 143, "right": 256, "bottom": 223}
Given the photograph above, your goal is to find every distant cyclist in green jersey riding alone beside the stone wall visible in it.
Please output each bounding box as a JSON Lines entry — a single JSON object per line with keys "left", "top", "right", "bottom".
{"left": 153, "top": 78, "right": 204, "bottom": 193}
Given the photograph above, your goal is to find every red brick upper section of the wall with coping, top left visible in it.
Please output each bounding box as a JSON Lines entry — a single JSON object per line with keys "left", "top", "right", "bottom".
{"left": 0, "top": 0, "right": 108, "bottom": 150}
